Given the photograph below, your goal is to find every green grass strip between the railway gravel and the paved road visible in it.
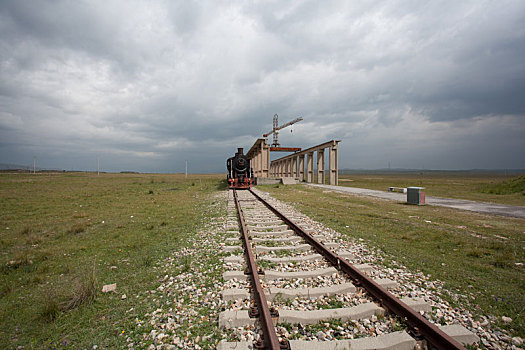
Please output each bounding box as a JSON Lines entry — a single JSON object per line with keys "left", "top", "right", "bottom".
{"left": 260, "top": 185, "right": 525, "bottom": 336}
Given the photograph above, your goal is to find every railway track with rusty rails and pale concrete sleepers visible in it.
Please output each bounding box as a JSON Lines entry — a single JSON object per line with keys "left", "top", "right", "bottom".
{"left": 218, "top": 190, "right": 479, "bottom": 349}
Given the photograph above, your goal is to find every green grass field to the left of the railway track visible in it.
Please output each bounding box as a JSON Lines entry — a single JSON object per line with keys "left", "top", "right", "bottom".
{"left": 0, "top": 173, "right": 225, "bottom": 348}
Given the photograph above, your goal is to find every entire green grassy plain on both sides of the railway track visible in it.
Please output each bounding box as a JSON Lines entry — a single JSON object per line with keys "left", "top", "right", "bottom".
{"left": 0, "top": 173, "right": 525, "bottom": 348}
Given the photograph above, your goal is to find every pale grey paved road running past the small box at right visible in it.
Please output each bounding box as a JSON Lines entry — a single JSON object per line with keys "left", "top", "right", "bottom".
{"left": 307, "top": 183, "right": 525, "bottom": 219}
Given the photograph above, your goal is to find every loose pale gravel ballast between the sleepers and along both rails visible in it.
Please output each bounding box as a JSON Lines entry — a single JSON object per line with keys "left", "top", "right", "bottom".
{"left": 124, "top": 191, "right": 523, "bottom": 349}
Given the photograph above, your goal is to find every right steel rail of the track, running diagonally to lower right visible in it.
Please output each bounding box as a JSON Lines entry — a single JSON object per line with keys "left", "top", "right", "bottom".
{"left": 250, "top": 189, "right": 465, "bottom": 350}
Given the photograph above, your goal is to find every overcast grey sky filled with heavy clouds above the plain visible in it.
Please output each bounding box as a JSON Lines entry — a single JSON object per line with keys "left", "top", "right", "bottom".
{"left": 0, "top": 0, "right": 525, "bottom": 172}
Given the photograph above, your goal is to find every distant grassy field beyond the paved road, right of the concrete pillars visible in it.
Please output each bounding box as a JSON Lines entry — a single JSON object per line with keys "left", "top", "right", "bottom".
{"left": 336, "top": 171, "right": 525, "bottom": 206}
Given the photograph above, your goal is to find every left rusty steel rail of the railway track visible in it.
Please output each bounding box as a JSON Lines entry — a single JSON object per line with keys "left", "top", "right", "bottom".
{"left": 233, "top": 189, "right": 280, "bottom": 350}
